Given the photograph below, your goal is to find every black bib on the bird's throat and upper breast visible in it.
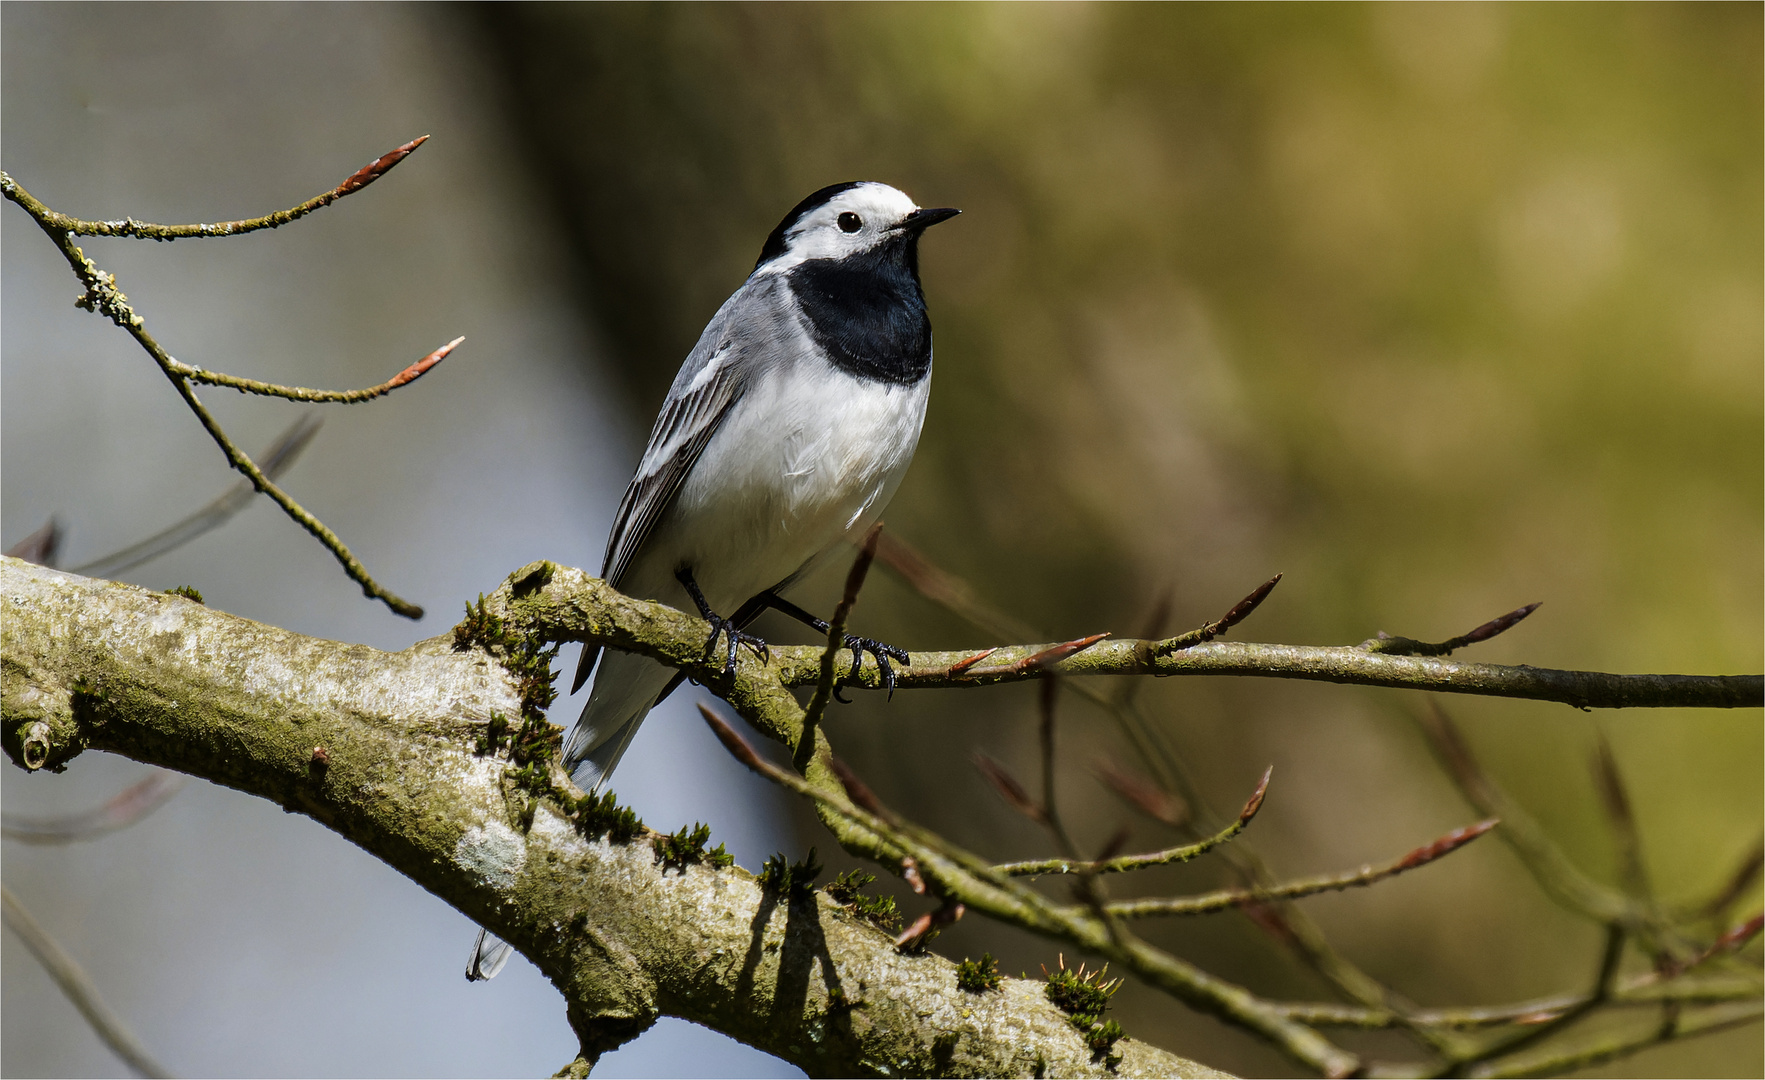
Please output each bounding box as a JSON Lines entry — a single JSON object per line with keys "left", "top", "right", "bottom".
{"left": 785, "top": 235, "right": 932, "bottom": 386}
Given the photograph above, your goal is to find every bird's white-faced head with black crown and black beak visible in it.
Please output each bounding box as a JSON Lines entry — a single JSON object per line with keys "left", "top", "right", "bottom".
{"left": 754, "top": 180, "right": 960, "bottom": 274}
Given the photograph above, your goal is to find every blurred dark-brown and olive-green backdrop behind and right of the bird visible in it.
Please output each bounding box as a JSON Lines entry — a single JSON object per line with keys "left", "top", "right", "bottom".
{"left": 477, "top": 4, "right": 1761, "bottom": 1075}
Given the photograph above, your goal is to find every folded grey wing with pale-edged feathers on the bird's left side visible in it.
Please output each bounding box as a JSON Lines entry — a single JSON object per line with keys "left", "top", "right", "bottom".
{"left": 570, "top": 333, "right": 745, "bottom": 694}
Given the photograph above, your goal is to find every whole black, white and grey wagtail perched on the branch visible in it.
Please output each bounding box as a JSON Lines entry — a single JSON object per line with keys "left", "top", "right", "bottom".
{"left": 466, "top": 182, "right": 957, "bottom": 979}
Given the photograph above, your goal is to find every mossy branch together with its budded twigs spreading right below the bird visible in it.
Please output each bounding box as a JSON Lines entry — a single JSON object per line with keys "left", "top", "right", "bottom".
{"left": 0, "top": 557, "right": 1765, "bottom": 1076}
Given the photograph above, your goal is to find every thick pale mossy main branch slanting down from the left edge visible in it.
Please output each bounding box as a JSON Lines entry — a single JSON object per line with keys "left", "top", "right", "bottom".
{"left": 0, "top": 559, "right": 1216, "bottom": 1076}
